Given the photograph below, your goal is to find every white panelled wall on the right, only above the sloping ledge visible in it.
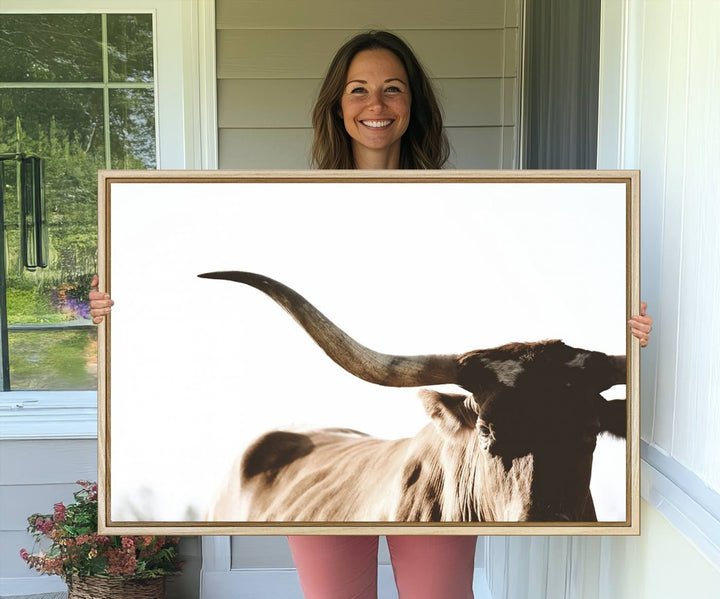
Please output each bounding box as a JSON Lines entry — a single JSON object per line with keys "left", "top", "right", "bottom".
{"left": 621, "top": 0, "right": 720, "bottom": 491}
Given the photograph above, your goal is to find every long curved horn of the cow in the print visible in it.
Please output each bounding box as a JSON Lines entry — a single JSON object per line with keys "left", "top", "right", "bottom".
{"left": 198, "top": 270, "right": 457, "bottom": 387}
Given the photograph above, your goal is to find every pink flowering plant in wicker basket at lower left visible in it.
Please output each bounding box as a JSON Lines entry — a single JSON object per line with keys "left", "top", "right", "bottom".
{"left": 20, "top": 481, "right": 182, "bottom": 599}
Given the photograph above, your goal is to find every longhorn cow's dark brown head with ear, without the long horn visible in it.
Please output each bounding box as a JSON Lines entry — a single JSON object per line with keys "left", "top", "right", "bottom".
{"left": 423, "top": 341, "right": 626, "bottom": 522}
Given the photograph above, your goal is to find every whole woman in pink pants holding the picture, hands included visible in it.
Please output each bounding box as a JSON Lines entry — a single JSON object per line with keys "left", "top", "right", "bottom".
{"left": 90, "top": 31, "right": 652, "bottom": 599}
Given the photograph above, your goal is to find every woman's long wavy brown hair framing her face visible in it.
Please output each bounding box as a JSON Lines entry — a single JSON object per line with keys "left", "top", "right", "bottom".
{"left": 312, "top": 31, "right": 450, "bottom": 169}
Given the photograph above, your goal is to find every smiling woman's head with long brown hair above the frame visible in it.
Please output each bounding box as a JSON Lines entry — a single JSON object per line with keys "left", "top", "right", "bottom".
{"left": 312, "top": 31, "right": 450, "bottom": 169}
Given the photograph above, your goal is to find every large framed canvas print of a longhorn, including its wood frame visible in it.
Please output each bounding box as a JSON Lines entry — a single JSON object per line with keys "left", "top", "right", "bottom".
{"left": 101, "top": 171, "right": 637, "bottom": 534}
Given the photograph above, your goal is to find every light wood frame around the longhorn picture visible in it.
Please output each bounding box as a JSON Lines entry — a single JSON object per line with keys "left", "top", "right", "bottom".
{"left": 98, "top": 171, "right": 640, "bottom": 535}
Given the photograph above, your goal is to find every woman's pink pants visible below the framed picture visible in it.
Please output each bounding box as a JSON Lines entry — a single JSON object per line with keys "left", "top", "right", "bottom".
{"left": 288, "top": 535, "right": 477, "bottom": 599}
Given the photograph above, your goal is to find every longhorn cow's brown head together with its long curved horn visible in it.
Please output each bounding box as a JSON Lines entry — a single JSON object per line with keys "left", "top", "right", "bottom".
{"left": 200, "top": 271, "right": 626, "bottom": 522}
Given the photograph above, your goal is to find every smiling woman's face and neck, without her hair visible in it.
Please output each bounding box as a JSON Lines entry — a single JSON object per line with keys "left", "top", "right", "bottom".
{"left": 340, "top": 49, "right": 411, "bottom": 168}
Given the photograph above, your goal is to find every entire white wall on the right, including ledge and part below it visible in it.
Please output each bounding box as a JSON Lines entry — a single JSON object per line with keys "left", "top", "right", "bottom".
{"left": 487, "top": 0, "right": 720, "bottom": 599}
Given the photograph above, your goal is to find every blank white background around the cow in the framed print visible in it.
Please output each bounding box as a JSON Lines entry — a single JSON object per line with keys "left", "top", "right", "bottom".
{"left": 105, "top": 182, "right": 626, "bottom": 521}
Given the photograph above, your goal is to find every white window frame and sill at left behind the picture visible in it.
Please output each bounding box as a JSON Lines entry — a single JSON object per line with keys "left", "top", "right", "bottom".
{"left": 0, "top": 0, "right": 217, "bottom": 440}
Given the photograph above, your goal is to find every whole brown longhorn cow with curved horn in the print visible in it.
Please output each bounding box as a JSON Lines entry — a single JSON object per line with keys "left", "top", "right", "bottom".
{"left": 199, "top": 271, "right": 626, "bottom": 522}
